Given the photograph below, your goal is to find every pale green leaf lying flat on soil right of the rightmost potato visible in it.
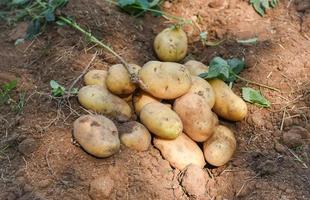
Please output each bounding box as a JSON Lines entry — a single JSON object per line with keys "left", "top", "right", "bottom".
{"left": 242, "top": 87, "right": 270, "bottom": 108}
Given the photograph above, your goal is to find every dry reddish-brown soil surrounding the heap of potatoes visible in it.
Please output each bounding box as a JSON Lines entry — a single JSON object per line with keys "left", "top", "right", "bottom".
{"left": 0, "top": 0, "right": 310, "bottom": 200}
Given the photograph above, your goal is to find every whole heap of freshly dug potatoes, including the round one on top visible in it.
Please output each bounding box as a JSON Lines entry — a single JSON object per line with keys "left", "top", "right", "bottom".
{"left": 73, "top": 28, "right": 247, "bottom": 170}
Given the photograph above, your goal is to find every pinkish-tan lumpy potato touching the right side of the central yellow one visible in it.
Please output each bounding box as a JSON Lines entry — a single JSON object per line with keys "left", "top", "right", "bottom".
{"left": 173, "top": 93, "right": 218, "bottom": 142}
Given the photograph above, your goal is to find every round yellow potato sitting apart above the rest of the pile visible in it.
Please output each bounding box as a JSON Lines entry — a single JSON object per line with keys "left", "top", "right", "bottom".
{"left": 154, "top": 28, "right": 188, "bottom": 62}
